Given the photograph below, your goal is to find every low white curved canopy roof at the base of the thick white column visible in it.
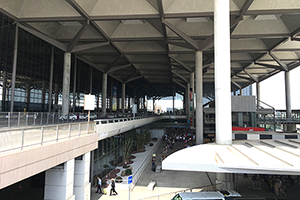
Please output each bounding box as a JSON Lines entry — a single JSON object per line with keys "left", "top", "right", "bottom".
{"left": 162, "top": 139, "right": 300, "bottom": 175}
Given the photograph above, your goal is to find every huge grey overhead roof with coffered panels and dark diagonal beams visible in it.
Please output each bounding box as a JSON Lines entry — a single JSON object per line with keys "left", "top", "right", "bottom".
{"left": 0, "top": 0, "right": 300, "bottom": 95}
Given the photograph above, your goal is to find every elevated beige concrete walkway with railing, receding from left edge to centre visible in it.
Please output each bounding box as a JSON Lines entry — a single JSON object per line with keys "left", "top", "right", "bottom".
{"left": 0, "top": 116, "right": 178, "bottom": 189}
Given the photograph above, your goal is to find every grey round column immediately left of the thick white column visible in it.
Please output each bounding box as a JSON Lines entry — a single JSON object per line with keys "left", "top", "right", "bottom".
{"left": 195, "top": 51, "right": 203, "bottom": 144}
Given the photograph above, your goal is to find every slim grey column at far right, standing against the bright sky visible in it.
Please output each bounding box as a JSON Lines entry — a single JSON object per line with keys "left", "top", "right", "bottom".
{"left": 284, "top": 72, "right": 292, "bottom": 132}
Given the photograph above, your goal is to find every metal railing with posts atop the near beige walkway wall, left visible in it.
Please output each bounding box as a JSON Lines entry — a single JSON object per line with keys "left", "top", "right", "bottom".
{"left": 0, "top": 122, "right": 95, "bottom": 153}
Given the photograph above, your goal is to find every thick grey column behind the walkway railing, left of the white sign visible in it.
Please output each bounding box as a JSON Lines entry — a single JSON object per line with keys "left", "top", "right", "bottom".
{"left": 61, "top": 52, "right": 71, "bottom": 115}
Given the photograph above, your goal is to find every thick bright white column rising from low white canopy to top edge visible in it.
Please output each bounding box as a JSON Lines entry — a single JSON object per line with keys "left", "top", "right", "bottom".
{"left": 214, "top": 0, "right": 232, "bottom": 144}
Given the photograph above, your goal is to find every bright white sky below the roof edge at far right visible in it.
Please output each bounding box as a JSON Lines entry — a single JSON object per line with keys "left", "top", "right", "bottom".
{"left": 253, "top": 67, "right": 300, "bottom": 110}
